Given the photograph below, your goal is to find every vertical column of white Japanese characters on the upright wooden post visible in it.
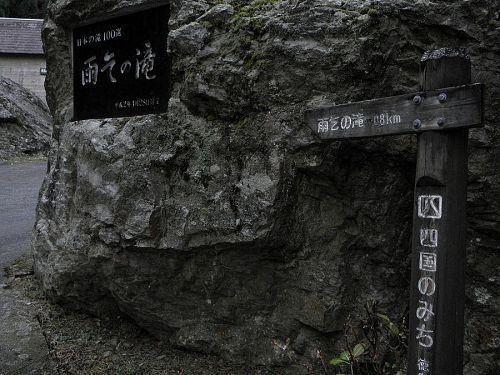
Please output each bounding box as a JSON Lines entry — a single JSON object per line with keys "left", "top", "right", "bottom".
{"left": 410, "top": 194, "right": 443, "bottom": 375}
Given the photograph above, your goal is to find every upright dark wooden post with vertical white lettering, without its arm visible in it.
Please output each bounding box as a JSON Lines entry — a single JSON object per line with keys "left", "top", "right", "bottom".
{"left": 407, "top": 49, "right": 471, "bottom": 375}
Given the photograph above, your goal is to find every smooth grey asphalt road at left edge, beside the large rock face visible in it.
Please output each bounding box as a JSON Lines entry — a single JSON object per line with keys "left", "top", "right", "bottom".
{"left": 0, "top": 162, "right": 47, "bottom": 278}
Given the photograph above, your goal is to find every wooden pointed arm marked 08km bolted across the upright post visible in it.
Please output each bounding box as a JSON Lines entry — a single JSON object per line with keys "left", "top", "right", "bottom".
{"left": 305, "top": 83, "right": 483, "bottom": 140}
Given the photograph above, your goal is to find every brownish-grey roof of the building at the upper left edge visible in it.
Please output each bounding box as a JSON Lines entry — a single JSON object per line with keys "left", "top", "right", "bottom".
{"left": 0, "top": 18, "right": 43, "bottom": 55}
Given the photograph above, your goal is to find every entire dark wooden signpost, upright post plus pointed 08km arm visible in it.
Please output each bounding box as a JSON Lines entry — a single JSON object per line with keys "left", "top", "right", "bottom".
{"left": 305, "top": 48, "right": 483, "bottom": 375}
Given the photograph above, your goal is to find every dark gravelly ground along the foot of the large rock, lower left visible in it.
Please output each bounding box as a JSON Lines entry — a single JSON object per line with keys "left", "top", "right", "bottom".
{"left": 6, "top": 255, "right": 285, "bottom": 375}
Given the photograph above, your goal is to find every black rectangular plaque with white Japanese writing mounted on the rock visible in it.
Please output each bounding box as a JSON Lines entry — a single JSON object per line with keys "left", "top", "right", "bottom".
{"left": 73, "top": 5, "right": 170, "bottom": 120}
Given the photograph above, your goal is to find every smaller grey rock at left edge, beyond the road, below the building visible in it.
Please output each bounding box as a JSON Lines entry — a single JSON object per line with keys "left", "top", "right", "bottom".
{"left": 0, "top": 77, "right": 52, "bottom": 160}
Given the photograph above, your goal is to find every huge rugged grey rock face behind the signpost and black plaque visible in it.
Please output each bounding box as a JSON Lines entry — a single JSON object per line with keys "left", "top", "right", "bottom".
{"left": 33, "top": 0, "right": 500, "bottom": 375}
